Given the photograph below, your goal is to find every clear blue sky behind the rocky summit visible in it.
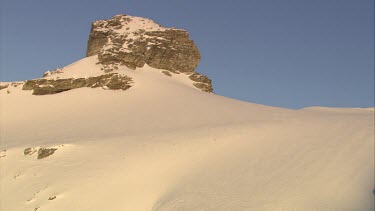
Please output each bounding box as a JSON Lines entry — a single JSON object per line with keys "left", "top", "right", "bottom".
{"left": 0, "top": 0, "right": 374, "bottom": 108}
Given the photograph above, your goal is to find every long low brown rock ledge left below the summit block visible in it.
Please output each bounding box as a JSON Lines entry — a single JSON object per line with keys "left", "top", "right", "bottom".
{"left": 22, "top": 73, "right": 132, "bottom": 95}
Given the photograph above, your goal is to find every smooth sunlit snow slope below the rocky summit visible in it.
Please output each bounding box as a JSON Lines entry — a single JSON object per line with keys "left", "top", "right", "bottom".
{"left": 0, "top": 56, "right": 374, "bottom": 211}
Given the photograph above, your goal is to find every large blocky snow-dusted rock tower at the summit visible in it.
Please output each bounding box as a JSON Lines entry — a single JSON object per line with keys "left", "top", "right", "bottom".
{"left": 86, "top": 15, "right": 200, "bottom": 72}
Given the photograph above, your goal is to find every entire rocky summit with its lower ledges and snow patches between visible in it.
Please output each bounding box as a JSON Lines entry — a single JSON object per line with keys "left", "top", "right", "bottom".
{"left": 0, "top": 15, "right": 213, "bottom": 95}
